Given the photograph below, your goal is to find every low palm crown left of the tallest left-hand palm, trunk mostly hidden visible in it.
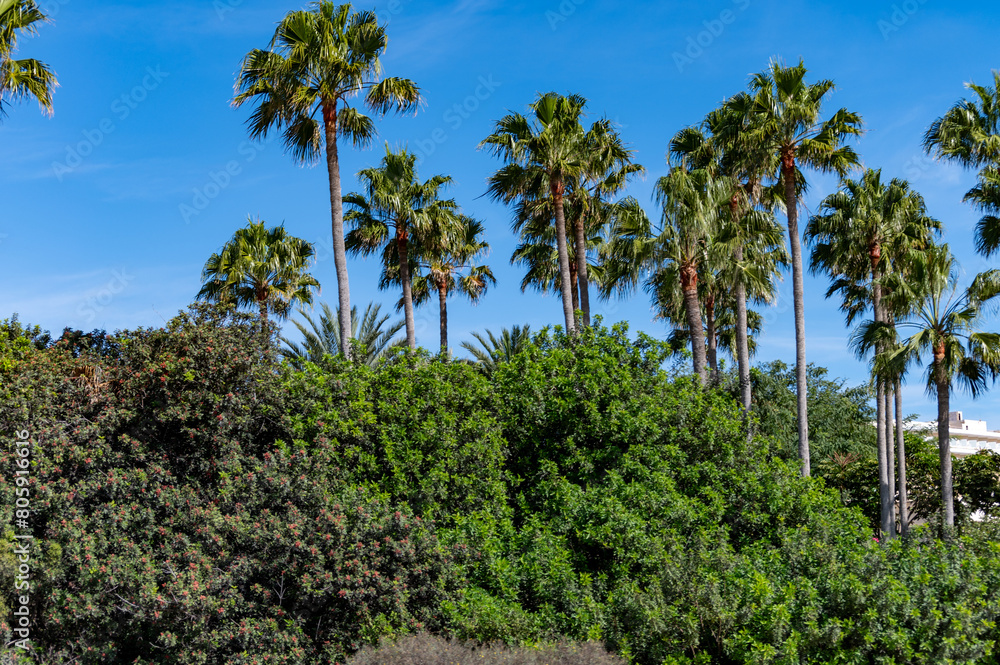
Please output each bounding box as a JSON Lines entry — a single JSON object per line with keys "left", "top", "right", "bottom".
{"left": 196, "top": 219, "right": 319, "bottom": 322}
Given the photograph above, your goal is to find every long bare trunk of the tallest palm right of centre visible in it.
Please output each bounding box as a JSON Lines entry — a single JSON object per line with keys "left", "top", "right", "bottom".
{"left": 781, "top": 156, "right": 809, "bottom": 476}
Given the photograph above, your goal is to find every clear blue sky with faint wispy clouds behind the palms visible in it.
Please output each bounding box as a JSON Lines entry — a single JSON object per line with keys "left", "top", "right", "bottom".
{"left": 0, "top": 0, "right": 1000, "bottom": 420}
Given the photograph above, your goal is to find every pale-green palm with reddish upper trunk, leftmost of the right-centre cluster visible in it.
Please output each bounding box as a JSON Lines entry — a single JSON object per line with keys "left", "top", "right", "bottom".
{"left": 605, "top": 165, "right": 731, "bottom": 385}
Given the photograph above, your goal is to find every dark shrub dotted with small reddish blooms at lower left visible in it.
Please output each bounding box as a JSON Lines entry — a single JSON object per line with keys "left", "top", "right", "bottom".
{"left": 0, "top": 307, "right": 461, "bottom": 663}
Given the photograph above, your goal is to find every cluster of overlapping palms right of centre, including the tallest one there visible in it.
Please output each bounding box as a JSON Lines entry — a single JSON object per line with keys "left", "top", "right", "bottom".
{"left": 584, "top": 61, "right": 861, "bottom": 475}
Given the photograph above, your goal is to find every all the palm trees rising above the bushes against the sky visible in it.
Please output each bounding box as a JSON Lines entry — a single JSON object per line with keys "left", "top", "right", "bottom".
{"left": 9, "top": 0, "right": 1000, "bottom": 536}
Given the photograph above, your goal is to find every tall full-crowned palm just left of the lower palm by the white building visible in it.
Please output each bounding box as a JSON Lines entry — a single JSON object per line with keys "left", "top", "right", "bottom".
{"left": 805, "top": 169, "right": 940, "bottom": 537}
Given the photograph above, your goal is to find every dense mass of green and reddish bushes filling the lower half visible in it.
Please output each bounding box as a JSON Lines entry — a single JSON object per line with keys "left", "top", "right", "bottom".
{"left": 0, "top": 306, "right": 1000, "bottom": 665}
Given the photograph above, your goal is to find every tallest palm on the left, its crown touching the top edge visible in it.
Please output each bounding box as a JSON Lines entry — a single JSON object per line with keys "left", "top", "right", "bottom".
{"left": 233, "top": 0, "right": 420, "bottom": 357}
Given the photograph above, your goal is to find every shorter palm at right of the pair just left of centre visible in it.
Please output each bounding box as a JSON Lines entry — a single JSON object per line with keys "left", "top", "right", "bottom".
{"left": 413, "top": 215, "right": 496, "bottom": 353}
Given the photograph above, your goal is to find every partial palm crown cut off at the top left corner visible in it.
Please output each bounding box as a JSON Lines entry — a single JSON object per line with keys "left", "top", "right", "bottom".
{"left": 0, "top": 0, "right": 59, "bottom": 117}
